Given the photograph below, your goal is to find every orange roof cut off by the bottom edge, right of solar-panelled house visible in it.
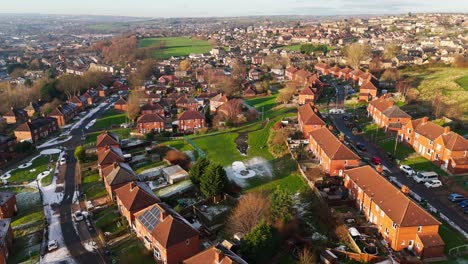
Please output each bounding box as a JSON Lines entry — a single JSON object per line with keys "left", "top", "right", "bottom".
{"left": 183, "top": 241, "right": 247, "bottom": 264}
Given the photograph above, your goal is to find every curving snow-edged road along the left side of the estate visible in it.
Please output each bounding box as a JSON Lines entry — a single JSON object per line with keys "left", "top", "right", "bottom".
{"left": 45, "top": 99, "right": 115, "bottom": 264}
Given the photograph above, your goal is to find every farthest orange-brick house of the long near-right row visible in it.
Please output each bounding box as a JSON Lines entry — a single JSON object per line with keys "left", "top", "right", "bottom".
{"left": 297, "top": 104, "right": 327, "bottom": 139}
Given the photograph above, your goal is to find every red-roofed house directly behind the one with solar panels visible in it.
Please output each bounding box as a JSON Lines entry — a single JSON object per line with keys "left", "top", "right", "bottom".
{"left": 115, "top": 181, "right": 161, "bottom": 227}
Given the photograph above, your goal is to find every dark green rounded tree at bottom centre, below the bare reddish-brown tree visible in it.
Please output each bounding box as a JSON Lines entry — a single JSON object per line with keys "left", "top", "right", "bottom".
{"left": 240, "top": 221, "right": 281, "bottom": 263}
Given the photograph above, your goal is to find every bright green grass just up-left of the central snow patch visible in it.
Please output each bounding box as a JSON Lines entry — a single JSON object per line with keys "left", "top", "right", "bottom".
{"left": 193, "top": 133, "right": 244, "bottom": 166}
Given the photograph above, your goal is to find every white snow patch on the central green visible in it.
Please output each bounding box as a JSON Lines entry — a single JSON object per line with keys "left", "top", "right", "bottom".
{"left": 224, "top": 157, "right": 273, "bottom": 187}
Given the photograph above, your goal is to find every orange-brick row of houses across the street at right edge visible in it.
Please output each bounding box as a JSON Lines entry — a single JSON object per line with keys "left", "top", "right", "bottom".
{"left": 367, "top": 97, "right": 468, "bottom": 174}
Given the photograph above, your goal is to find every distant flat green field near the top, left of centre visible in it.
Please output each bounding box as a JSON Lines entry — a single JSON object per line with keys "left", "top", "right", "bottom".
{"left": 139, "top": 37, "right": 212, "bottom": 59}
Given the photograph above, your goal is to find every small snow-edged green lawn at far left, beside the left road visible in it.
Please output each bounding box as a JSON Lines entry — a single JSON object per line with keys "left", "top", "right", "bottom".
{"left": 8, "top": 155, "right": 56, "bottom": 184}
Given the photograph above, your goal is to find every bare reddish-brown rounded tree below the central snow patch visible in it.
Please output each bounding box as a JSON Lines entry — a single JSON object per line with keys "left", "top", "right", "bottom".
{"left": 227, "top": 192, "right": 270, "bottom": 235}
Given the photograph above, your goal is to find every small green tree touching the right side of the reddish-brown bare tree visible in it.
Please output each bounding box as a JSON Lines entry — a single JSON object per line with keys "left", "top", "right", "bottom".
{"left": 270, "top": 186, "right": 293, "bottom": 223}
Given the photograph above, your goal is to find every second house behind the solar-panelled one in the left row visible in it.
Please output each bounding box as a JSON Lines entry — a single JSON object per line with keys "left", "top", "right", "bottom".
{"left": 102, "top": 162, "right": 139, "bottom": 199}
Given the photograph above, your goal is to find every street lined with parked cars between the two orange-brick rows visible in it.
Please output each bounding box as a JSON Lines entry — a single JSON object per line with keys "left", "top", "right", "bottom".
{"left": 330, "top": 115, "right": 468, "bottom": 233}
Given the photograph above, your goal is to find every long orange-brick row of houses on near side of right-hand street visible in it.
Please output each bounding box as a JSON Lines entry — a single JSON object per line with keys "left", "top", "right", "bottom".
{"left": 298, "top": 104, "right": 444, "bottom": 257}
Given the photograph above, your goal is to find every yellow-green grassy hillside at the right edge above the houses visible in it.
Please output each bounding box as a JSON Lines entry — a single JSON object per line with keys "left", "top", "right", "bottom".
{"left": 404, "top": 68, "right": 468, "bottom": 121}
